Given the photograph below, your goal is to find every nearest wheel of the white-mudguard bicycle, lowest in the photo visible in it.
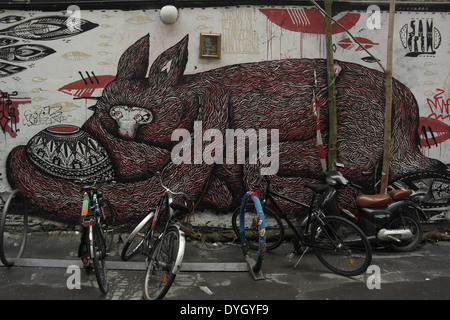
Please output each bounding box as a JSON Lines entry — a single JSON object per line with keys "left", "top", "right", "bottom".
{"left": 144, "top": 227, "right": 184, "bottom": 300}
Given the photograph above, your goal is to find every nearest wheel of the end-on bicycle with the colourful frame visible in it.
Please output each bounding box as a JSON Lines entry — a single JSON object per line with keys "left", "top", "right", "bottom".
{"left": 89, "top": 224, "right": 108, "bottom": 294}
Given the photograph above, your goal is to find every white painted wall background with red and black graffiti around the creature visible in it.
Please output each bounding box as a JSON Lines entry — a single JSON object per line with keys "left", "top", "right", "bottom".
{"left": 0, "top": 6, "right": 450, "bottom": 222}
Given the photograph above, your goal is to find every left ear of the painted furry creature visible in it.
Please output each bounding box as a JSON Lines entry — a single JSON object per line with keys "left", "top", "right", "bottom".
{"left": 116, "top": 34, "right": 150, "bottom": 79}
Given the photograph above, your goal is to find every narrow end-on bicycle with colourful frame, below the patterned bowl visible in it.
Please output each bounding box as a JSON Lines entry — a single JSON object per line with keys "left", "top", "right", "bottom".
{"left": 78, "top": 179, "right": 115, "bottom": 294}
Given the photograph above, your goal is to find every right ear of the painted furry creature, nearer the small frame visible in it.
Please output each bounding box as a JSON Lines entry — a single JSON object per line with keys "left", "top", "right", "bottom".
{"left": 148, "top": 35, "right": 189, "bottom": 88}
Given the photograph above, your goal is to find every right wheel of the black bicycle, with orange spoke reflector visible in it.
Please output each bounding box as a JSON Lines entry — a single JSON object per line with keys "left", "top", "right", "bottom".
{"left": 311, "top": 216, "right": 372, "bottom": 277}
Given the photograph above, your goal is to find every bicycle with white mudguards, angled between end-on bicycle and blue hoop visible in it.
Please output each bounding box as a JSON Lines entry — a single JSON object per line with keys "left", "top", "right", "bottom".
{"left": 128, "top": 170, "right": 190, "bottom": 300}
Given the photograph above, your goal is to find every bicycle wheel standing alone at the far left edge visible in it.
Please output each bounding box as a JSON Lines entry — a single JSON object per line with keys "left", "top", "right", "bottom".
{"left": 0, "top": 189, "right": 28, "bottom": 267}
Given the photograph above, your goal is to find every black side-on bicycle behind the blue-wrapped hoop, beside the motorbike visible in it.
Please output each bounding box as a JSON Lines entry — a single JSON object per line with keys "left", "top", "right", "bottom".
{"left": 232, "top": 176, "right": 372, "bottom": 276}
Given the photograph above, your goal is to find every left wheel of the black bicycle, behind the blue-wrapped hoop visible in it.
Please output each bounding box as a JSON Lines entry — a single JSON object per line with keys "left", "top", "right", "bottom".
{"left": 231, "top": 203, "right": 284, "bottom": 251}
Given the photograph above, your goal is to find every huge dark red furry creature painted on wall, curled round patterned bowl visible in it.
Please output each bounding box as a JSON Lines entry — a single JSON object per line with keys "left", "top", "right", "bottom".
{"left": 7, "top": 35, "right": 446, "bottom": 221}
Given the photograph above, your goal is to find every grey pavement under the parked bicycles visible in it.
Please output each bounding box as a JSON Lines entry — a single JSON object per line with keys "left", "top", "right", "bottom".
{"left": 0, "top": 232, "right": 450, "bottom": 302}
